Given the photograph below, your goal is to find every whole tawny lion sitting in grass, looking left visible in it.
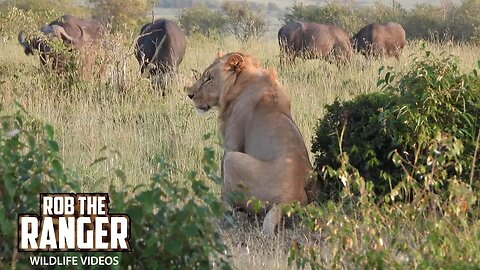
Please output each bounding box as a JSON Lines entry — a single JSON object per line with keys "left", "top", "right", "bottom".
{"left": 188, "top": 52, "right": 312, "bottom": 235}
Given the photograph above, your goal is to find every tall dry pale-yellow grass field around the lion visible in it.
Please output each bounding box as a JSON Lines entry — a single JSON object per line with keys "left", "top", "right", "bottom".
{"left": 0, "top": 33, "right": 480, "bottom": 269}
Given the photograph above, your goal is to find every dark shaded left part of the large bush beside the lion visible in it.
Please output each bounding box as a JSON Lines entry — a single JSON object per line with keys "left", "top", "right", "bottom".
{"left": 312, "top": 93, "right": 401, "bottom": 201}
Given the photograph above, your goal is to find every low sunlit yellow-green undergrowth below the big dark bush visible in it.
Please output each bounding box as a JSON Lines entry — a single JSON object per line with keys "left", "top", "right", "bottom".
{"left": 287, "top": 175, "right": 480, "bottom": 269}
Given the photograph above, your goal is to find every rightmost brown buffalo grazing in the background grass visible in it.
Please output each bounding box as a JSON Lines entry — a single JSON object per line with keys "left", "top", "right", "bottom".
{"left": 352, "top": 22, "right": 407, "bottom": 59}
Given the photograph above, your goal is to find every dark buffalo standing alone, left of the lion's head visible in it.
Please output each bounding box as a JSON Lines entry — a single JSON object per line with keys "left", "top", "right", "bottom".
{"left": 135, "top": 19, "right": 186, "bottom": 75}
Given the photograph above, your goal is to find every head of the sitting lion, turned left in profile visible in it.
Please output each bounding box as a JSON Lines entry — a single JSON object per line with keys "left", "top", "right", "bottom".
{"left": 188, "top": 53, "right": 259, "bottom": 113}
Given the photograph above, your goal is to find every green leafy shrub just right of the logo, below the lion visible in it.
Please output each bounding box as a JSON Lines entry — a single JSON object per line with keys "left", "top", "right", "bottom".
{"left": 110, "top": 155, "right": 230, "bottom": 269}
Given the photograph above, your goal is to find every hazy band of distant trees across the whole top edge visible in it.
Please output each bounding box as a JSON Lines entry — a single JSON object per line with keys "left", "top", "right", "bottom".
{"left": 0, "top": 0, "right": 480, "bottom": 44}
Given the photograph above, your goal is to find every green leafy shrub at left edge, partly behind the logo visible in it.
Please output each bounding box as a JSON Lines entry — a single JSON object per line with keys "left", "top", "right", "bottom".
{"left": 0, "top": 107, "right": 79, "bottom": 269}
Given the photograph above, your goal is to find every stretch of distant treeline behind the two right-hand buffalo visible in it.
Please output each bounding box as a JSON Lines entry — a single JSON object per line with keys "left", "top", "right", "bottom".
{"left": 283, "top": 0, "right": 480, "bottom": 43}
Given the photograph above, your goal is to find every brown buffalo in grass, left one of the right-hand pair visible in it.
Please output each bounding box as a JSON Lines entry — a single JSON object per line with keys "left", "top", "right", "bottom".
{"left": 278, "top": 22, "right": 352, "bottom": 64}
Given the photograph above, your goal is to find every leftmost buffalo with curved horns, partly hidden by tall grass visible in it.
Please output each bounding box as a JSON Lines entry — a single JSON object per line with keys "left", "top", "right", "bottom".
{"left": 18, "top": 15, "right": 105, "bottom": 68}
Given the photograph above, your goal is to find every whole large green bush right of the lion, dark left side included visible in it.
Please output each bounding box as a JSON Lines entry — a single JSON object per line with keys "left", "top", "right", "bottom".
{"left": 312, "top": 46, "right": 480, "bottom": 200}
